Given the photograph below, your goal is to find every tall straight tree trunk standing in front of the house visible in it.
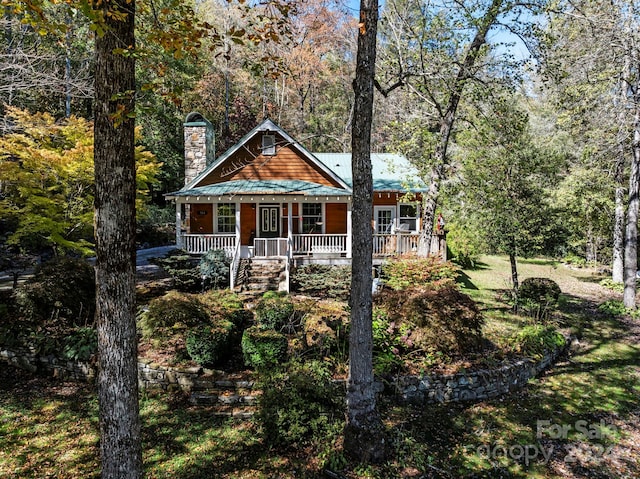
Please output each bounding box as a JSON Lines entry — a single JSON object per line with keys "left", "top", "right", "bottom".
{"left": 344, "top": 0, "right": 386, "bottom": 462}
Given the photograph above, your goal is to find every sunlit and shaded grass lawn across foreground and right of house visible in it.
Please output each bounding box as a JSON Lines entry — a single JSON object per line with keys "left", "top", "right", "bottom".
{"left": 0, "top": 257, "right": 640, "bottom": 479}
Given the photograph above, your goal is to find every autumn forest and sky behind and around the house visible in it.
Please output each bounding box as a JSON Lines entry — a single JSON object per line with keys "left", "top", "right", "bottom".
{"left": 0, "top": 0, "right": 640, "bottom": 288}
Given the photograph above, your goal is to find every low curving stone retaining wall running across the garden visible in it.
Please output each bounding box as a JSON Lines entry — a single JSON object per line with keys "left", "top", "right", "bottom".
{"left": 0, "top": 341, "right": 569, "bottom": 407}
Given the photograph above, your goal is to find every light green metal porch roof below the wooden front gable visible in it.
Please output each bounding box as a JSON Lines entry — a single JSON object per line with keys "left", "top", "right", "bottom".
{"left": 166, "top": 180, "right": 351, "bottom": 197}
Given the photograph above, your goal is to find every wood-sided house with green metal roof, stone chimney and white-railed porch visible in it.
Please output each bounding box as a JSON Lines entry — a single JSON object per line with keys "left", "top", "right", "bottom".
{"left": 166, "top": 113, "right": 446, "bottom": 289}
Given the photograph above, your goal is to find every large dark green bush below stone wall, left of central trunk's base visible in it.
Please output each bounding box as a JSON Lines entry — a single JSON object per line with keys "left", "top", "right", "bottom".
{"left": 256, "top": 361, "right": 344, "bottom": 448}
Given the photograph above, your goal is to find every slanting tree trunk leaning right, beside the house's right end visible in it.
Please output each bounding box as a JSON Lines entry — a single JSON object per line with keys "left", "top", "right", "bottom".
{"left": 418, "top": 0, "right": 504, "bottom": 256}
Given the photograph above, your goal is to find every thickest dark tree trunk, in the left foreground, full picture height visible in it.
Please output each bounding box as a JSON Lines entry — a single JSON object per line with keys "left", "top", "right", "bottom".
{"left": 94, "top": 0, "right": 142, "bottom": 479}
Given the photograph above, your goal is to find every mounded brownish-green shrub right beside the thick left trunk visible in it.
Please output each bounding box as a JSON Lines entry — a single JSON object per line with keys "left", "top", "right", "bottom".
{"left": 138, "top": 291, "right": 209, "bottom": 340}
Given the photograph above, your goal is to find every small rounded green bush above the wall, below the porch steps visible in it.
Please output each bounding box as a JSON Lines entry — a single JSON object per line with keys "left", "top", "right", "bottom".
{"left": 241, "top": 326, "right": 288, "bottom": 371}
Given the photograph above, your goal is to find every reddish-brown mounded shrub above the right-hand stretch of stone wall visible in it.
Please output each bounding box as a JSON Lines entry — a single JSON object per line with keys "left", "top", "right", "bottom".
{"left": 375, "top": 286, "right": 484, "bottom": 354}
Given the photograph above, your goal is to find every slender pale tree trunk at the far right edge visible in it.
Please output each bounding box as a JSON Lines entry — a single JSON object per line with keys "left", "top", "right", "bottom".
{"left": 623, "top": 103, "right": 640, "bottom": 309}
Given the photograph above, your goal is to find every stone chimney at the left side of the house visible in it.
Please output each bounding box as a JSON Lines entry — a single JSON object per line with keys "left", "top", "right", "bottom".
{"left": 184, "top": 112, "right": 216, "bottom": 185}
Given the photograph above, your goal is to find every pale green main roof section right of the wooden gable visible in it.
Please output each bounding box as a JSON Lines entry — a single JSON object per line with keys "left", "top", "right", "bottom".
{"left": 313, "top": 153, "right": 427, "bottom": 193}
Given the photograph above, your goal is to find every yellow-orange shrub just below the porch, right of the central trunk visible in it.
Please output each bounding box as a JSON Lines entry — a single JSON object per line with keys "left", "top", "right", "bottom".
{"left": 382, "top": 257, "right": 458, "bottom": 290}
